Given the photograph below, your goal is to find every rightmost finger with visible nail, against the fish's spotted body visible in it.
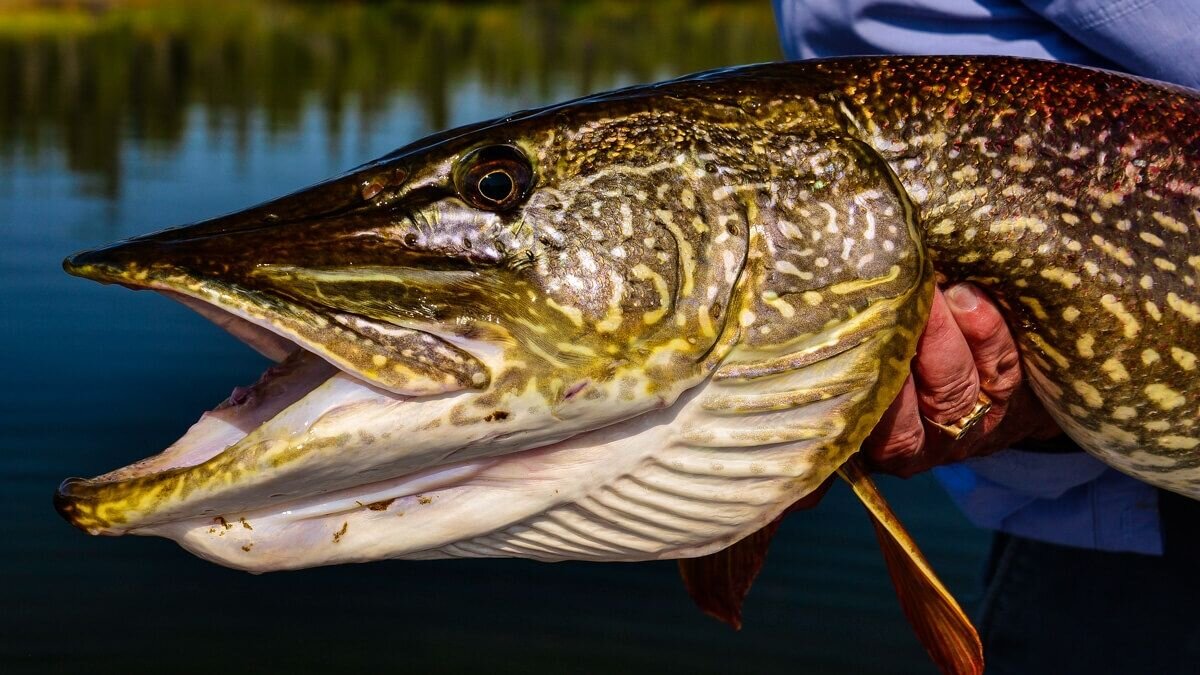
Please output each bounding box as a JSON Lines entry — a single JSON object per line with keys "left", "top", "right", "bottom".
{"left": 946, "top": 278, "right": 1021, "bottom": 404}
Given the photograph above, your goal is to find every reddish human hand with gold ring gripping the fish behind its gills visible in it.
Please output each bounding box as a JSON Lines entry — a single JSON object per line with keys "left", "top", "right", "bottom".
{"left": 863, "top": 283, "right": 1062, "bottom": 478}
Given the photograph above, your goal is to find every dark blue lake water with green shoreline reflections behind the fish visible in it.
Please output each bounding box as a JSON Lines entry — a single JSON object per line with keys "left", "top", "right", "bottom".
{"left": 0, "top": 1, "right": 986, "bottom": 673}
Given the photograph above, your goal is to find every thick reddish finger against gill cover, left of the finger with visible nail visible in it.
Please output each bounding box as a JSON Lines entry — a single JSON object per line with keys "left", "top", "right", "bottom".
{"left": 913, "top": 291, "right": 979, "bottom": 424}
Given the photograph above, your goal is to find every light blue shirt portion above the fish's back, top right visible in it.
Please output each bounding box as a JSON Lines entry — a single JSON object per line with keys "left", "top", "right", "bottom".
{"left": 774, "top": 0, "right": 1200, "bottom": 88}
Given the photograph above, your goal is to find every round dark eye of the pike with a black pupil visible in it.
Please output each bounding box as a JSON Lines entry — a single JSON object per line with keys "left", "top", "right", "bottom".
{"left": 455, "top": 145, "right": 533, "bottom": 211}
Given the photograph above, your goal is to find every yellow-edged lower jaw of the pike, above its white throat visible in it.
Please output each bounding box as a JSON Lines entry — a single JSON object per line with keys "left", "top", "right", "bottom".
{"left": 55, "top": 307, "right": 710, "bottom": 538}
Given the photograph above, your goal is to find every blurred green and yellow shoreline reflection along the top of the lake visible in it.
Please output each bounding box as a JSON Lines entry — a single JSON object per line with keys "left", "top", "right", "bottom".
{"left": 0, "top": 0, "right": 780, "bottom": 197}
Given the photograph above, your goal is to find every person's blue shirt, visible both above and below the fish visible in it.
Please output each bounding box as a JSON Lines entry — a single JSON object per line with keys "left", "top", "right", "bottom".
{"left": 774, "top": 0, "right": 1200, "bottom": 554}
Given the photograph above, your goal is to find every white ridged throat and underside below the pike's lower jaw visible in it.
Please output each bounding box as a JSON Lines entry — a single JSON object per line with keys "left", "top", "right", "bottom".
{"left": 103, "top": 374, "right": 839, "bottom": 573}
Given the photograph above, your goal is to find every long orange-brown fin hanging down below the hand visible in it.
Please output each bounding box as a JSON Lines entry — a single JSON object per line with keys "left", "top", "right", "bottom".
{"left": 838, "top": 456, "right": 983, "bottom": 675}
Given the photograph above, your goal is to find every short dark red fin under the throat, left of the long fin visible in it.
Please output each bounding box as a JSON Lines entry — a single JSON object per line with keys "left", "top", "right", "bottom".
{"left": 679, "top": 515, "right": 784, "bottom": 631}
